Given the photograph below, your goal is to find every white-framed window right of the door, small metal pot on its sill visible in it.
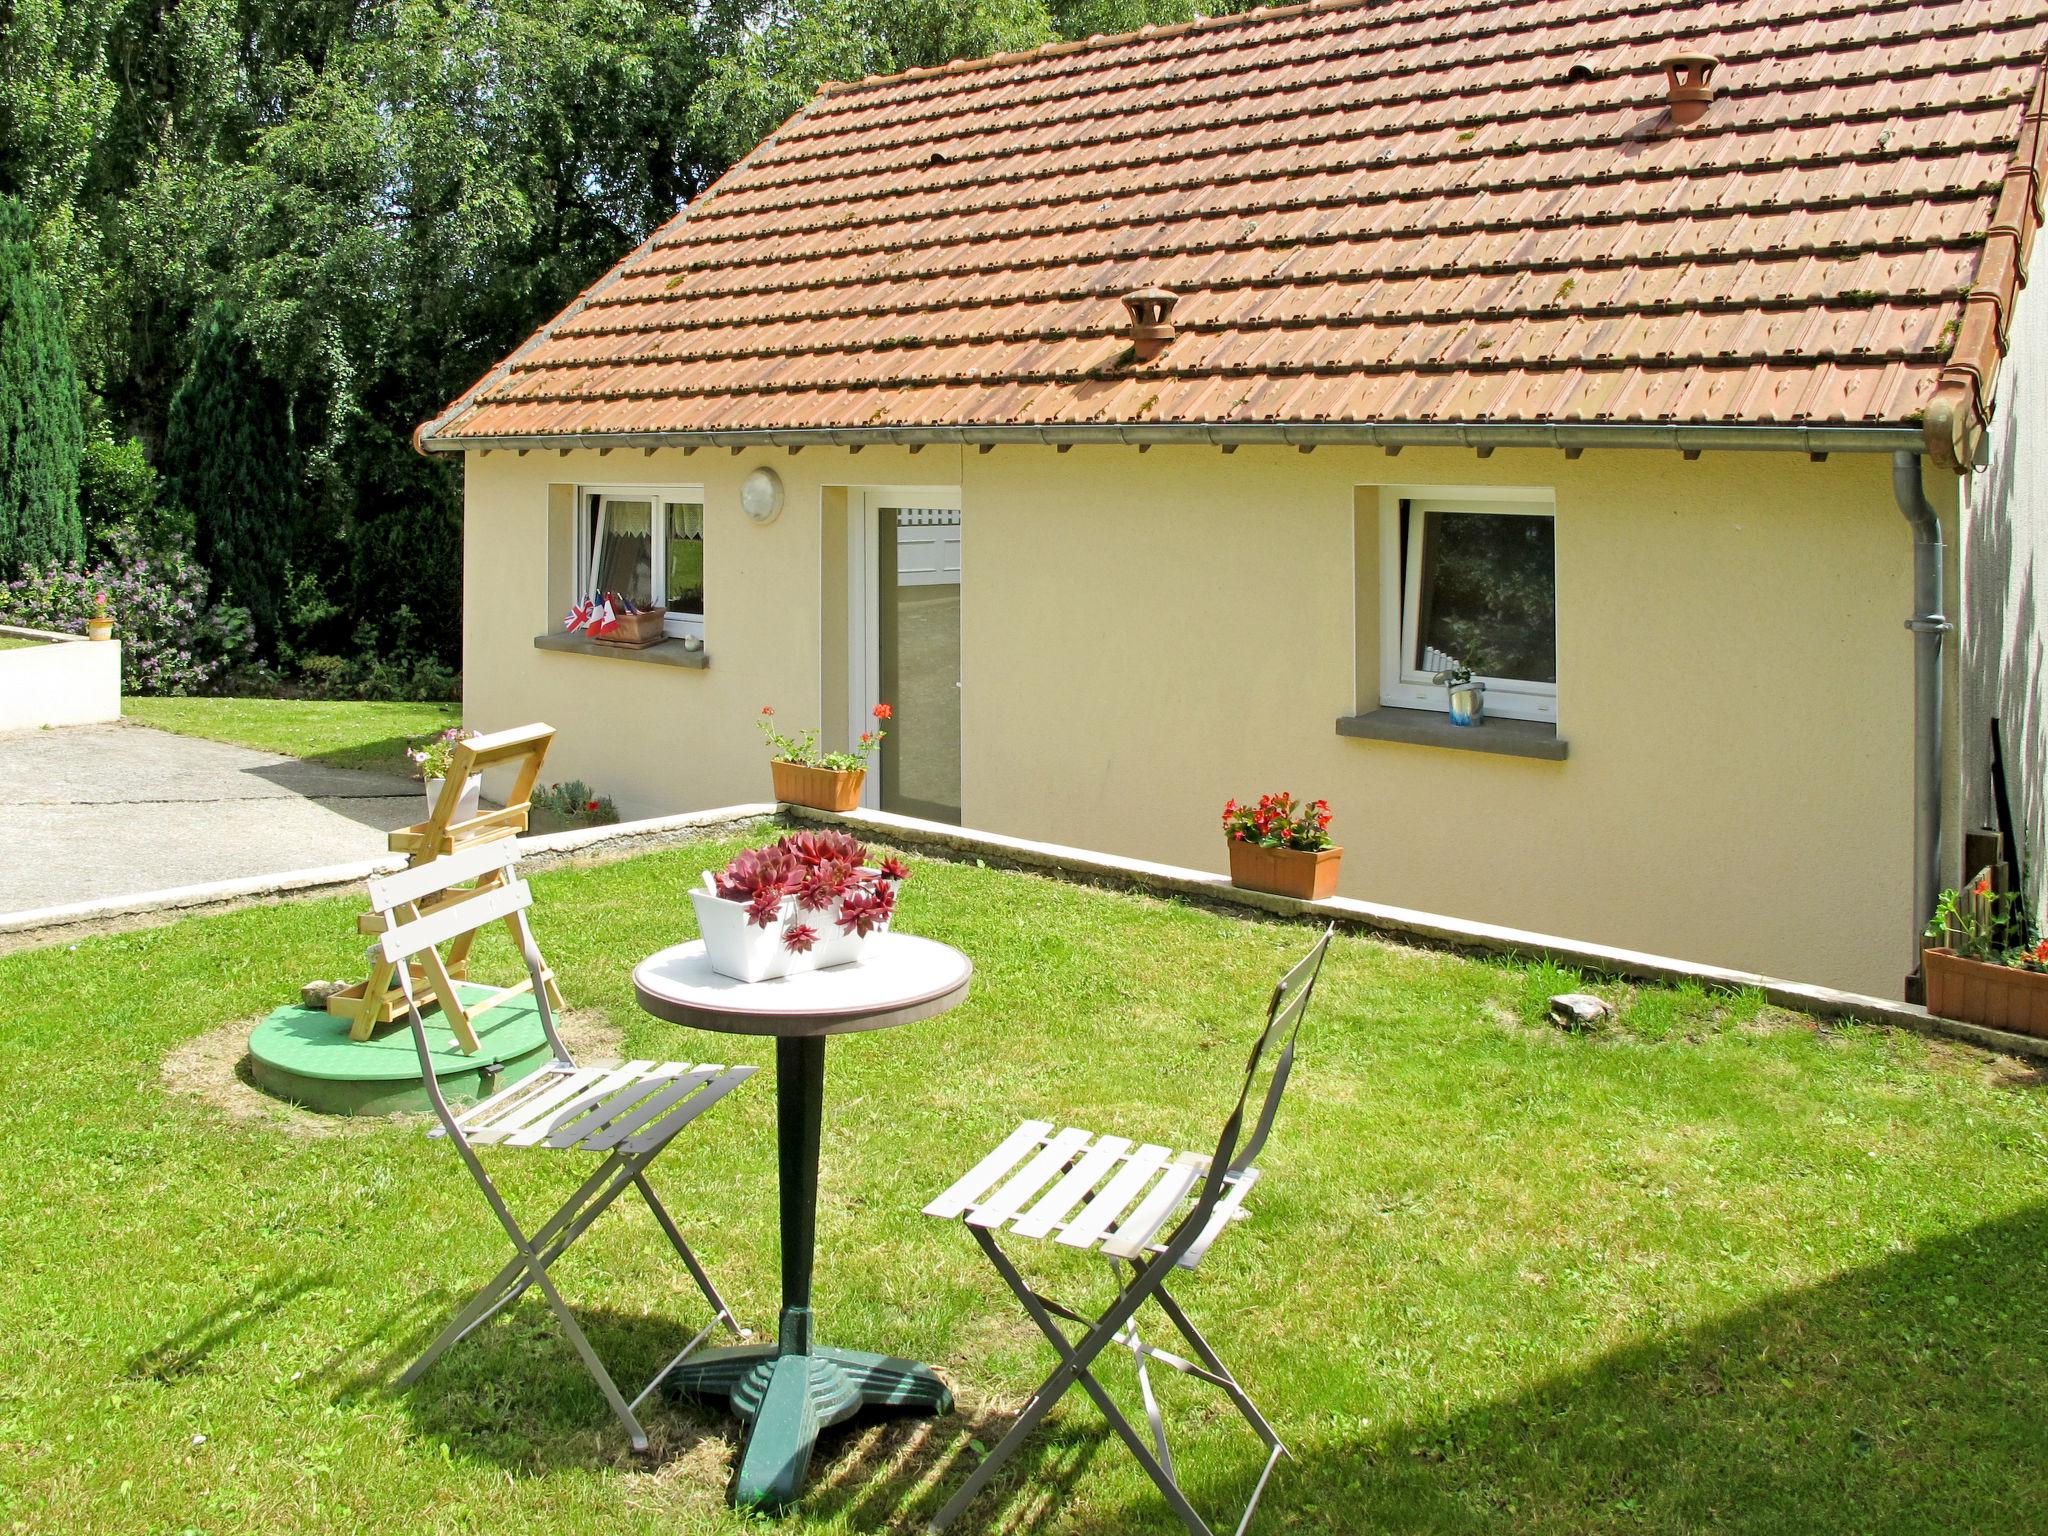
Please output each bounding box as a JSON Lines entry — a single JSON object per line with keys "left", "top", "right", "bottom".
{"left": 1380, "top": 489, "right": 1556, "bottom": 721}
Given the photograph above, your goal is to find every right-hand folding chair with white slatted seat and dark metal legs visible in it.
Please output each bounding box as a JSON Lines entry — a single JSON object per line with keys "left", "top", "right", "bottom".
{"left": 924, "top": 928, "right": 1333, "bottom": 1536}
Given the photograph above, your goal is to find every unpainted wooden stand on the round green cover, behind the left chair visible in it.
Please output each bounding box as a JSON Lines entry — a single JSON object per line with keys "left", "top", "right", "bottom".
{"left": 328, "top": 725, "right": 563, "bottom": 1051}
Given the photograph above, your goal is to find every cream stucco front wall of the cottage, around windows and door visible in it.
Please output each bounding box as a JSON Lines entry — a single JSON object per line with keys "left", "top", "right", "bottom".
{"left": 465, "top": 446, "right": 1911, "bottom": 995}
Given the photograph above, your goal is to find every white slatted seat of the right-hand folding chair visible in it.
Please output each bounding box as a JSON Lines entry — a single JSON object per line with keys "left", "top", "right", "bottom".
{"left": 924, "top": 1120, "right": 1260, "bottom": 1270}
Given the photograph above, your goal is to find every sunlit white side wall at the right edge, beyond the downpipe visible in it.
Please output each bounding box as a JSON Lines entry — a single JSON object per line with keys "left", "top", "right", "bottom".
{"left": 1944, "top": 270, "right": 2048, "bottom": 933}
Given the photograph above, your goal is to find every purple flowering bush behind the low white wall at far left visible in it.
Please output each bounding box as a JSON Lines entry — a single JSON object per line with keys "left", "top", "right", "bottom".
{"left": 0, "top": 526, "right": 256, "bottom": 694}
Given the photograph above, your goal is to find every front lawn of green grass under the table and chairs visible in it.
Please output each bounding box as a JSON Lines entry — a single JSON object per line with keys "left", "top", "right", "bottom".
{"left": 0, "top": 844, "right": 2048, "bottom": 1536}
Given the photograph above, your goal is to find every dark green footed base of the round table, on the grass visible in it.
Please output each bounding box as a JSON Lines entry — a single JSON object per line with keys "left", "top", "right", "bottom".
{"left": 662, "top": 1343, "right": 952, "bottom": 1511}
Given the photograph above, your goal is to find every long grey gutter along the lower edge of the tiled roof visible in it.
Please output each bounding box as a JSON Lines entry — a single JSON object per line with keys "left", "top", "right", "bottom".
{"left": 414, "top": 412, "right": 1927, "bottom": 455}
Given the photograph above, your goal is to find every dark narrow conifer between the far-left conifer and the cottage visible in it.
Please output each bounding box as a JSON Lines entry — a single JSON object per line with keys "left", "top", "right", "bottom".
{"left": 164, "top": 303, "right": 303, "bottom": 649}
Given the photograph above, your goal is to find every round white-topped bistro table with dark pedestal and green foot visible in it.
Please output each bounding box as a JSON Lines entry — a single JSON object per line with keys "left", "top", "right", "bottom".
{"left": 633, "top": 934, "right": 975, "bottom": 1511}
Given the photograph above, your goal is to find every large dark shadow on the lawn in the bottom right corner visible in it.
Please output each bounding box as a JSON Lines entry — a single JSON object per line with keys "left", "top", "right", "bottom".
{"left": 1270, "top": 1192, "right": 2048, "bottom": 1534}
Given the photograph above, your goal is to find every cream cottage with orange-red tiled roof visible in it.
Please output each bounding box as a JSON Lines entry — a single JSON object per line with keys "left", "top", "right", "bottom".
{"left": 418, "top": 0, "right": 2048, "bottom": 995}
